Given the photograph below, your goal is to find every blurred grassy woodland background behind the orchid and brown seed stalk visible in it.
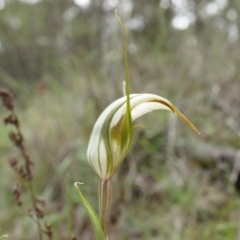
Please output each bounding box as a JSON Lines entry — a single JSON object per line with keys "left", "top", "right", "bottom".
{"left": 0, "top": 0, "right": 240, "bottom": 240}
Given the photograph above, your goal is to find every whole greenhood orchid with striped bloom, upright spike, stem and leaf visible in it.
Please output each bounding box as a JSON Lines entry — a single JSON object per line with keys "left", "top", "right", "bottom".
{"left": 75, "top": 11, "right": 199, "bottom": 240}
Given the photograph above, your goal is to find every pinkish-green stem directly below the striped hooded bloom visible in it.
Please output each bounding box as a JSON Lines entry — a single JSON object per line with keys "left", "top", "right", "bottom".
{"left": 98, "top": 180, "right": 112, "bottom": 235}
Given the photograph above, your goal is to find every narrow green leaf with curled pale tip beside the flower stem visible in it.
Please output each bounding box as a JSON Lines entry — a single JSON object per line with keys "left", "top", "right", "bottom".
{"left": 74, "top": 182, "right": 107, "bottom": 240}
